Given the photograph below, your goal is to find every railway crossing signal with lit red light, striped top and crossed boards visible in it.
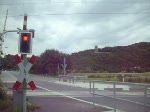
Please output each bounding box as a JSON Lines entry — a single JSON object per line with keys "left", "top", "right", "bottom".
{"left": 9, "top": 14, "right": 37, "bottom": 112}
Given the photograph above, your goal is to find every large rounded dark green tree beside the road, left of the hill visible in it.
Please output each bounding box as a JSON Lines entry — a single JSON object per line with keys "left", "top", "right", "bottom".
{"left": 33, "top": 49, "right": 67, "bottom": 75}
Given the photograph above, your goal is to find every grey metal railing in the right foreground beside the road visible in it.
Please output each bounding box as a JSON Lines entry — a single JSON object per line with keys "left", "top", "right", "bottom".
{"left": 89, "top": 81, "right": 150, "bottom": 107}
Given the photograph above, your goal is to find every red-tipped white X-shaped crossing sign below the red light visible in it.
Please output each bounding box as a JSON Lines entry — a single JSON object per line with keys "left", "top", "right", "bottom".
{"left": 13, "top": 55, "right": 36, "bottom": 90}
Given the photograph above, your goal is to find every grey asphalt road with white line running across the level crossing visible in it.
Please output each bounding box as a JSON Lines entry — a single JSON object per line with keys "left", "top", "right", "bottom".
{"left": 0, "top": 71, "right": 150, "bottom": 112}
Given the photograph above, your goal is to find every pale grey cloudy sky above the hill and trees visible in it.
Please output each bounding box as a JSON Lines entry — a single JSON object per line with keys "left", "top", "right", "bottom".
{"left": 0, "top": 0, "right": 150, "bottom": 55}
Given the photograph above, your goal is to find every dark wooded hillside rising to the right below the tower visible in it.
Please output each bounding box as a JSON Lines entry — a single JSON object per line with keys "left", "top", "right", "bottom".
{"left": 70, "top": 42, "right": 150, "bottom": 72}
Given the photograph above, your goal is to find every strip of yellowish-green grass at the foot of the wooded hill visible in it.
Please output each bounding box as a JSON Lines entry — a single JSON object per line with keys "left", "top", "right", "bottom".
{"left": 70, "top": 73, "right": 150, "bottom": 83}
